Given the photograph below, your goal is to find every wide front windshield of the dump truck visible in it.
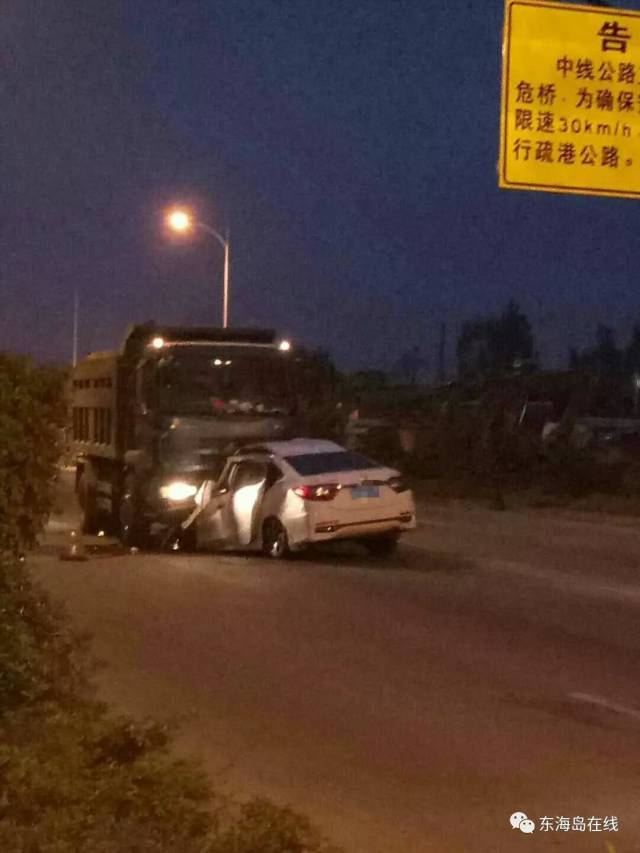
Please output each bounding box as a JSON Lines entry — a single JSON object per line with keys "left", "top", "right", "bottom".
{"left": 157, "top": 345, "right": 293, "bottom": 417}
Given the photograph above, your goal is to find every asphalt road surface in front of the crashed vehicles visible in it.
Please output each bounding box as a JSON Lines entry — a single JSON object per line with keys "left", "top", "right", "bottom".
{"left": 31, "top": 476, "right": 640, "bottom": 853}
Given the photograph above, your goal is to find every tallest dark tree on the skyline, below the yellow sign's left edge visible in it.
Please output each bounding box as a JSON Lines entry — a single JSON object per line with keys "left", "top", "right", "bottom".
{"left": 457, "top": 301, "right": 534, "bottom": 379}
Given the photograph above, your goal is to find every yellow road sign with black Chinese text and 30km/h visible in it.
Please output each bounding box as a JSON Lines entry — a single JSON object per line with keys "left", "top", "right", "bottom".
{"left": 499, "top": 0, "right": 640, "bottom": 197}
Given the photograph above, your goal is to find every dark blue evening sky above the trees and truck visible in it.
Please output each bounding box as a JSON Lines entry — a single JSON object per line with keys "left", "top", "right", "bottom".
{"left": 0, "top": 0, "right": 640, "bottom": 367}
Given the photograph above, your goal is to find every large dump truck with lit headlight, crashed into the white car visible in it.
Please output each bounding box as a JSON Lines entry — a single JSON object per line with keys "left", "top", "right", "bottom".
{"left": 71, "top": 324, "right": 299, "bottom": 546}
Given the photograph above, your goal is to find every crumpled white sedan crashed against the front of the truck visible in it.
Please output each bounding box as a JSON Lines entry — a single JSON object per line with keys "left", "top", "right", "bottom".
{"left": 183, "top": 438, "right": 415, "bottom": 559}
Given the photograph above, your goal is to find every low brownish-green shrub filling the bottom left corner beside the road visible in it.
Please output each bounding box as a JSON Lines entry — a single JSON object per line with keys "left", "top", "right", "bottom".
{"left": 0, "top": 703, "right": 212, "bottom": 853}
